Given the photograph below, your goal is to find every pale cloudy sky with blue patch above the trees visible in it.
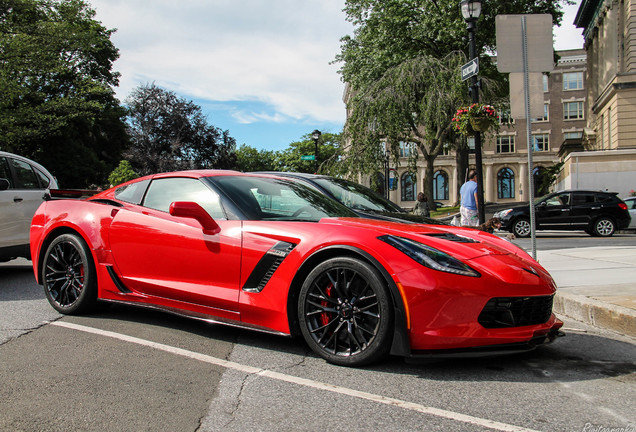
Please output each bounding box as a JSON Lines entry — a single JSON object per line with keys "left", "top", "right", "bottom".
{"left": 87, "top": 0, "right": 583, "bottom": 150}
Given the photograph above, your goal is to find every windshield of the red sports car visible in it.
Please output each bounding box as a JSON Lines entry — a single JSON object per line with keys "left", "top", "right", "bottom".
{"left": 208, "top": 176, "right": 358, "bottom": 222}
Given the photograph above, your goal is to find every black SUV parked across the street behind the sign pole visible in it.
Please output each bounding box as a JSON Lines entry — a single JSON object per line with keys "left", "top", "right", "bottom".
{"left": 493, "top": 190, "right": 631, "bottom": 237}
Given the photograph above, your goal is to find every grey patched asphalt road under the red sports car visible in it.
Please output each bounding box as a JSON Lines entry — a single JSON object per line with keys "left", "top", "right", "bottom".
{"left": 0, "top": 248, "right": 636, "bottom": 431}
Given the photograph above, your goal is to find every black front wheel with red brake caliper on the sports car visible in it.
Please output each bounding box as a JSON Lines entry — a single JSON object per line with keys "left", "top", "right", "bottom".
{"left": 298, "top": 257, "right": 393, "bottom": 366}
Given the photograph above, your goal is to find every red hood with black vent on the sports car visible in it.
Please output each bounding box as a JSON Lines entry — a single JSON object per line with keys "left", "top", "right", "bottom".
{"left": 320, "top": 218, "right": 535, "bottom": 262}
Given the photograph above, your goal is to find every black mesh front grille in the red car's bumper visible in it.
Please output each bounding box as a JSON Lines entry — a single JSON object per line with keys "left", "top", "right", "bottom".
{"left": 478, "top": 296, "right": 554, "bottom": 328}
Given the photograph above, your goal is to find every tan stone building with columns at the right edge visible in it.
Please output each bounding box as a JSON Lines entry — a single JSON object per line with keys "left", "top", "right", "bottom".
{"left": 557, "top": 0, "right": 636, "bottom": 197}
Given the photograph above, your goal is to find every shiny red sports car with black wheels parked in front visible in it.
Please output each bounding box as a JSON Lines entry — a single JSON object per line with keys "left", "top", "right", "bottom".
{"left": 31, "top": 171, "right": 562, "bottom": 366}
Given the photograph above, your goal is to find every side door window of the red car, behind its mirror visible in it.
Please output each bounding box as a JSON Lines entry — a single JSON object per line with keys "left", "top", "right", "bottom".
{"left": 143, "top": 177, "right": 226, "bottom": 219}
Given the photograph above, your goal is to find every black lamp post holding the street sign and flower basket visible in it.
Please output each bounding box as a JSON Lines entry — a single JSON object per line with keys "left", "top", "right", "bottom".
{"left": 460, "top": 0, "right": 486, "bottom": 224}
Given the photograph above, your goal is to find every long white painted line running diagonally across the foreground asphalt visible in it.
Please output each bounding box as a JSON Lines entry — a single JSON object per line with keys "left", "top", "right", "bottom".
{"left": 51, "top": 321, "right": 537, "bottom": 432}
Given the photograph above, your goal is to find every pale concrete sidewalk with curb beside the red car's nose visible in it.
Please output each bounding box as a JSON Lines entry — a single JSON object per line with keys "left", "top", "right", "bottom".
{"left": 537, "top": 247, "right": 636, "bottom": 337}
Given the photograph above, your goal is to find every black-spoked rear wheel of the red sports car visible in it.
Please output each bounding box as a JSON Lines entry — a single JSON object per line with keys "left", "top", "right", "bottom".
{"left": 42, "top": 234, "right": 97, "bottom": 314}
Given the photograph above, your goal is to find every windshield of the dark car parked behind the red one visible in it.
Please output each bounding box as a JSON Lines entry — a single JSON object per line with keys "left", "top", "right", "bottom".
{"left": 314, "top": 178, "right": 404, "bottom": 213}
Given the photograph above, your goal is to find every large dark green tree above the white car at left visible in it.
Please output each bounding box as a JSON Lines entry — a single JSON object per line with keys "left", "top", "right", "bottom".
{"left": 0, "top": 0, "right": 128, "bottom": 187}
